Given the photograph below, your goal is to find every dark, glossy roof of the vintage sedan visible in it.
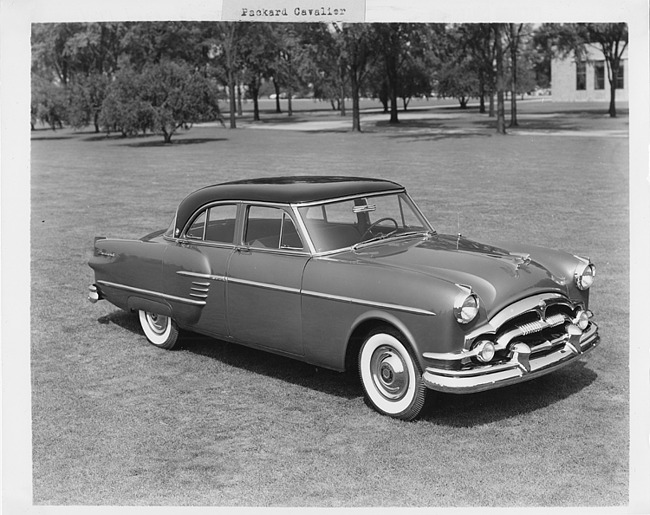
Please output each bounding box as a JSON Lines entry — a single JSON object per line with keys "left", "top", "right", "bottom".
{"left": 176, "top": 176, "right": 404, "bottom": 234}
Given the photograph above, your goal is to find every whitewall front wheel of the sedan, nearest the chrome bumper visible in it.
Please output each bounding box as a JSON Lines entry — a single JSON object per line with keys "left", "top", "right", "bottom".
{"left": 359, "top": 328, "right": 427, "bottom": 420}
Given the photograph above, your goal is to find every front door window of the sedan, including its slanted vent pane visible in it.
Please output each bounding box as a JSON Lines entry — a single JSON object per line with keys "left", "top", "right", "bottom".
{"left": 244, "top": 206, "right": 303, "bottom": 250}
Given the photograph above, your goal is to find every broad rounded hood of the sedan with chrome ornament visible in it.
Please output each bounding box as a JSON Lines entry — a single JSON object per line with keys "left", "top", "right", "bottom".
{"left": 339, "top": 234, "right": 570, "bottom": 311}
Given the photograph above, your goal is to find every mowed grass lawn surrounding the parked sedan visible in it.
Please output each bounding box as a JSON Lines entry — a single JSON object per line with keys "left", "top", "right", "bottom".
{"left": 31, "top": 103, "right": 629, "bottom": 506}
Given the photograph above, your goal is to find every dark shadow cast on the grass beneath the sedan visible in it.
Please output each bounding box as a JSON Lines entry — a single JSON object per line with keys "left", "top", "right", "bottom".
{"left": 98, "top": 310, "right": 598, "bottom": 427}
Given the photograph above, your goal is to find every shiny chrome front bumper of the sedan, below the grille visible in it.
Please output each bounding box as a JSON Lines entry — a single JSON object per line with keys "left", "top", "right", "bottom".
{"left": 422, "top": 322, "right": 600, "bottom": 393}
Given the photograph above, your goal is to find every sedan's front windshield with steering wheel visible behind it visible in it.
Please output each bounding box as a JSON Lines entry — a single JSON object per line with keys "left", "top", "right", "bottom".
{"left": 298, "top": 193, "right": 433, "bottom": 252}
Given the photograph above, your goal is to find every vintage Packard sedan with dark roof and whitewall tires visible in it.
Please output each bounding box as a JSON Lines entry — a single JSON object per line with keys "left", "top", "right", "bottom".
{"left": 89, "top": 177, "right": 599, "bottom": 420}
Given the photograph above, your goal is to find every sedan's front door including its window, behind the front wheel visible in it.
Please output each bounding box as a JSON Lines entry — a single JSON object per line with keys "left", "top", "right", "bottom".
{"left": 226, "top": 205, "right": 310, "bottom": 356}
